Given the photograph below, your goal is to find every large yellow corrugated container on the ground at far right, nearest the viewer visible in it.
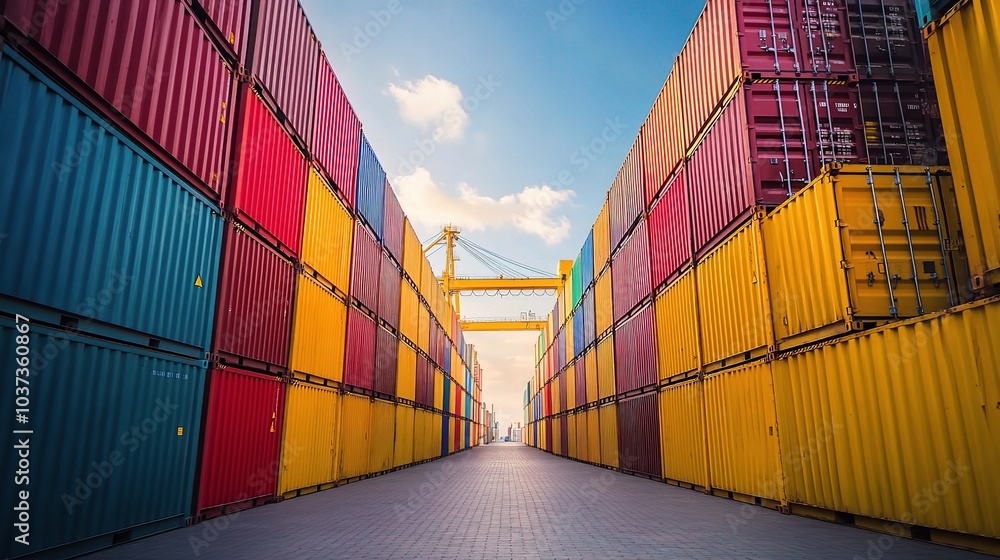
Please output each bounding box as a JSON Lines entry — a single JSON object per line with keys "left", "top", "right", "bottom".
{"left": 774, "top": 298, "right": 1000, "bottom": 538}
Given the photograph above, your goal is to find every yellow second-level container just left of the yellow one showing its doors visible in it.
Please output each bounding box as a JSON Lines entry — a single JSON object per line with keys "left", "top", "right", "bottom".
{"left": 695, "top": 213, "right": 773, "bottom": 370}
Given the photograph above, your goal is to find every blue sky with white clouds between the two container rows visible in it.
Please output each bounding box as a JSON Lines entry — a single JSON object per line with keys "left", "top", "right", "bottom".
{"left": 300, "top": 0, "right": 704, "bottom": 430}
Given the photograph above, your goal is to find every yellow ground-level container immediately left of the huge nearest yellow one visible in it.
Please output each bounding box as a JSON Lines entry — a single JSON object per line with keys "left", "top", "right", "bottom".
{"left": 705, "top": 362, "right": 785, "bottom": 503}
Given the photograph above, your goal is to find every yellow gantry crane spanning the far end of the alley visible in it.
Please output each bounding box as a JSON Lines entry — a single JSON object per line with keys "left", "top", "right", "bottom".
{"left": 423, "top": 224, "right": 573, "bottom": 332}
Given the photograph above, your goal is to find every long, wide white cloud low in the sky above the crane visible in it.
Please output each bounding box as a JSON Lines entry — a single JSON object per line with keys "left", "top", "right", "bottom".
{"left": 392, "top": 167, "right": 575, "bottom": 245}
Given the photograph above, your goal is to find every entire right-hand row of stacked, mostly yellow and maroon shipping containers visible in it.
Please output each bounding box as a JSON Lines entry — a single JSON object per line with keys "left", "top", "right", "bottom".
{"left": 524, "top": 0, "right": 1000, "bottom": 548}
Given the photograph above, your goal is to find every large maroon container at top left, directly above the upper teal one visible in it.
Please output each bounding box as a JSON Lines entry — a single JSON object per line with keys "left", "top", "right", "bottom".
{"left": 0, "top": 0, "right": 234, "bottom": 200}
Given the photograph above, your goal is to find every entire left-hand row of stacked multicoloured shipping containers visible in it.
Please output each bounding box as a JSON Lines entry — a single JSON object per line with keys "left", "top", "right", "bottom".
{"left": 0, "top": 0, "right": 485, "bottom": 558}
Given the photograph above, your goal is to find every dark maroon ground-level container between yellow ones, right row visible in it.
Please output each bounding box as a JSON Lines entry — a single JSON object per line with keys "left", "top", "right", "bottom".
{"left": 618, "top": 392, "right": 662, "bottom": 478}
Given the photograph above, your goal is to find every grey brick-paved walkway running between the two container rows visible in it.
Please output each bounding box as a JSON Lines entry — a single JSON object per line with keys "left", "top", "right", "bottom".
{"left": 89, "top": 444, "right": 987, "bottom": 560}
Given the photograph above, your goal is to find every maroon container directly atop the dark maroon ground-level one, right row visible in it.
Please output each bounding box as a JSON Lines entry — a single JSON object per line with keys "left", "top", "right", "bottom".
{"left": 615, "top": 305, "right": 659, "bottom": 395}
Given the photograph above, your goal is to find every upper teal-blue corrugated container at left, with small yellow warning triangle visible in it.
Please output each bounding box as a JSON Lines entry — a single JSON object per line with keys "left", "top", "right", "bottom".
{"left": 0, "top": 51, "right": 223, "bottom": 356}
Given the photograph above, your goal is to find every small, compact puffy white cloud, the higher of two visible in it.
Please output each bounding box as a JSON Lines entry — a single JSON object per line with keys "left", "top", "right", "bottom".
{"left": 389, "top": 74, "right": 469, "bottom": 141}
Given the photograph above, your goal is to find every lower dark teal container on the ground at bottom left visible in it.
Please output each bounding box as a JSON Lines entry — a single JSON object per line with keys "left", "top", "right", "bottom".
{"left": 0, "top": 317, "right": 205, "bottom": 557}
